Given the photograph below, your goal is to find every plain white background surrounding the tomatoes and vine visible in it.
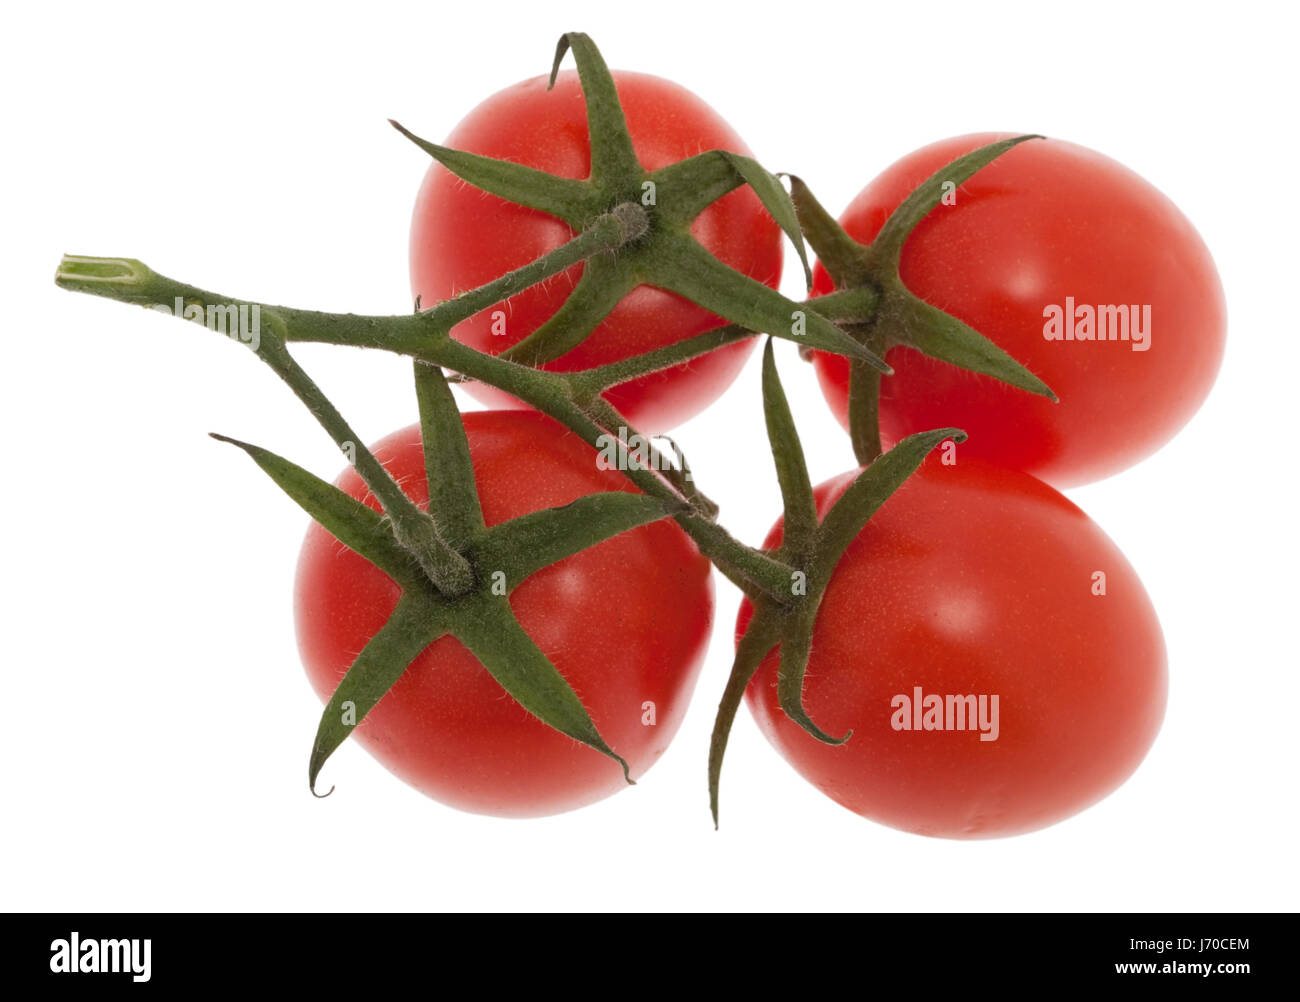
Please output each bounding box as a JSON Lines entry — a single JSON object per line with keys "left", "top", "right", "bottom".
{"left": 0, "top": 0, "right": 1300, "bottom": 910}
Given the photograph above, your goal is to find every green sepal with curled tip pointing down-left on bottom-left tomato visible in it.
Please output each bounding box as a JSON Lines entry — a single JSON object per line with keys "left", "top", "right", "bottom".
{"left": 307, "top": 594, "right": 447, "bottom": 797}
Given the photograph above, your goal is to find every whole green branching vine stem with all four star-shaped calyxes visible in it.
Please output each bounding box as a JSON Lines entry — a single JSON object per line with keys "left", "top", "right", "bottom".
{"left": 56, "top": 34, "right": 1050, "bottom": 821}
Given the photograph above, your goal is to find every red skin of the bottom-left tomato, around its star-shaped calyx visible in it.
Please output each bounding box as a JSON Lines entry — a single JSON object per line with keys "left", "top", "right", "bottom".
{"left": 295, "top": 411, "right": 712, "bottom": 816}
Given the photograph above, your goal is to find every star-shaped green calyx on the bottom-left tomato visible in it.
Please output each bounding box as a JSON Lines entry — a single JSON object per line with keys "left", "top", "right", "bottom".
{"left": 215, "top": 363, "right": 666, "bottom": 790}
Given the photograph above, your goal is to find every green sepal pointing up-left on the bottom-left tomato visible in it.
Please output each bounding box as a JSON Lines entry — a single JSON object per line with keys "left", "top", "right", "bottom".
{"left": 212, "top": 431, "right": 424, "bottom": 587}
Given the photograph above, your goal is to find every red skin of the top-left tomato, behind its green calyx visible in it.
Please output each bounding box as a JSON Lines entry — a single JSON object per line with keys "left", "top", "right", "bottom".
{"left": 411, "top": 71, "right": 781, "bottom": 434}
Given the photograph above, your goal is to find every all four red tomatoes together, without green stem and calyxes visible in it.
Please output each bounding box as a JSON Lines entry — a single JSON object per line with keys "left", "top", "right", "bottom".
{"left": 284, "top": 62, "right": 1225, "bottom": 837}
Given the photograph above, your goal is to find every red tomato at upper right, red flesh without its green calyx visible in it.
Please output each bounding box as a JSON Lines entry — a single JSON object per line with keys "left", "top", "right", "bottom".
{"left": 815, "top": 134, "right": 1226, "bottom": 487}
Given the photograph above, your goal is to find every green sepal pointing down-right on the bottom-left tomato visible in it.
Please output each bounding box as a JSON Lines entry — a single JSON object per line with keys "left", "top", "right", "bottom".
{"left": 455, "top": 598, "right": 633, "bottom": 784}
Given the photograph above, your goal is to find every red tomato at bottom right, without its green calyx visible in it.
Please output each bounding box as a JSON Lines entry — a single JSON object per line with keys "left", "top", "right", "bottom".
{"left": 738, "top": 454, "right": 1166, "bottom": 838}
